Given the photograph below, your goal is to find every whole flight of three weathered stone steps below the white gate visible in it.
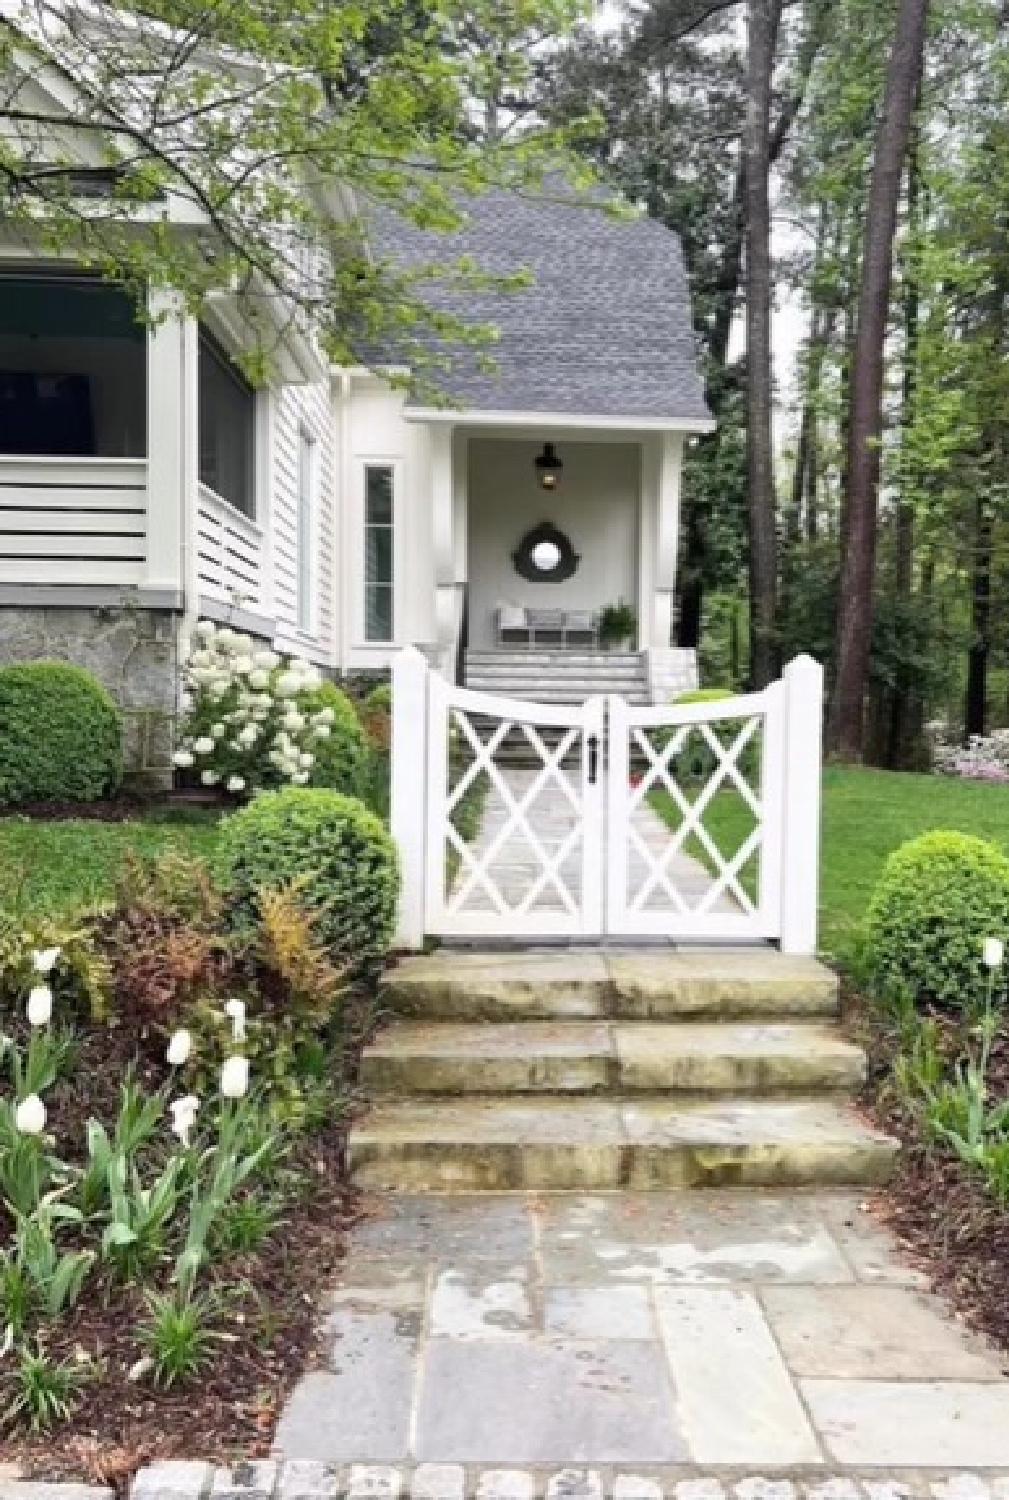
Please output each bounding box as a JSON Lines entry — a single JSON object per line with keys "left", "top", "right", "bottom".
{"left": 348, "top": 947, "right": 895, "bottom": 1193}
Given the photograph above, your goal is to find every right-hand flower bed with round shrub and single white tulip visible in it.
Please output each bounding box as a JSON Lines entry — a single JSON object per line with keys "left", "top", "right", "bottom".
{"left": 847, "top": 834, "right": 1009, "bottom": 1350}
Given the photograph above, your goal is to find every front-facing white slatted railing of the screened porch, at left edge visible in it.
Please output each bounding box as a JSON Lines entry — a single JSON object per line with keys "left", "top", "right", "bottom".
{"left": 0, "top": 456, "right": 147, "bottom": 585}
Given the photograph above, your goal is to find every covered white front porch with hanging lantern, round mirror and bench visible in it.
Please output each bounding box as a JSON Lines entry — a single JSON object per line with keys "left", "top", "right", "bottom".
{"left": 413, "top": 416, "right": 696, "bottom": 702}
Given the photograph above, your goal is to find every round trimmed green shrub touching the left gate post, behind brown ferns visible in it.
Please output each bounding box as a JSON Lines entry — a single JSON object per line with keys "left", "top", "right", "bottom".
{"left": 216, "top": 786, "right": 399, "bottom": 963}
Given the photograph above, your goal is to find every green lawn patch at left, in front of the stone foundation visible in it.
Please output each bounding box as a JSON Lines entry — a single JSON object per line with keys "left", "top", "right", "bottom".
{"left": 0, "top": 810, "right": 217, "bottom": 915}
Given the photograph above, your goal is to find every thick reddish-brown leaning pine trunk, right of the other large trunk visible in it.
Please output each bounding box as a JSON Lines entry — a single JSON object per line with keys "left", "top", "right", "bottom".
{"left": 829, "top": 0, "right": 928, "bottom": 761}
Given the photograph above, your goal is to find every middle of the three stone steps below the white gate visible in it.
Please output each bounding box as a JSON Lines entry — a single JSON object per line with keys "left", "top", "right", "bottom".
{"left": 361, "top": 1022, "right": 865, "bottom": 1098}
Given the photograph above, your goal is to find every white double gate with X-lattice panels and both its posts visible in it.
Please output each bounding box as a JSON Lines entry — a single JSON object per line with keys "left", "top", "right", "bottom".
{"left": 393, "top": 651, "right": 823, "bottom": 953}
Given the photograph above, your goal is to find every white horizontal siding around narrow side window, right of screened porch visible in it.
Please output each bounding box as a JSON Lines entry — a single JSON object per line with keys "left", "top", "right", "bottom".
{"left": 270, "top": 381, "right": 336, "bottom": 665}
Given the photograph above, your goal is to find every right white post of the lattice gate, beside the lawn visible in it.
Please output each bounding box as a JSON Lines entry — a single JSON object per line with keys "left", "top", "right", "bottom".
{"left": 781, "top": 656, "right": 823, "bottom": 954}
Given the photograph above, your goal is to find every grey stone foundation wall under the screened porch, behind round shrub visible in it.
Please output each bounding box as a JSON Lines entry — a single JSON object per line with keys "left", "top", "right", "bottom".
{"left": 0, "top": 605, "right": 180, "bottom": 791}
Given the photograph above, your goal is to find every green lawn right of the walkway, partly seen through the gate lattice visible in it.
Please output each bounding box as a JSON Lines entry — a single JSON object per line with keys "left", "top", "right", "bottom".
{"left": 652, "top": 767, "right": 1009, "bottom": 953}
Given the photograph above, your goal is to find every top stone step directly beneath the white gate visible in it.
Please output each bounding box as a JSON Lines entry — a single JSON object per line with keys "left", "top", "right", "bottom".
{"left": 382, "top": 947, "right": 838, "bottom": 1022}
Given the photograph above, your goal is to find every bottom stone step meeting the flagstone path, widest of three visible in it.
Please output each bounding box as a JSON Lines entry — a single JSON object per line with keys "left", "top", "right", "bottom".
{"left": 348, "top": 1097, "right": 895, "bottom": 1193}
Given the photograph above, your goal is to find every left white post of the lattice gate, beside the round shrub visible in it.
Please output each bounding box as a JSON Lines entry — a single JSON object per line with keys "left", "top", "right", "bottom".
{"left": 390, "top": 647, "right": 430, "bottom": 950}
